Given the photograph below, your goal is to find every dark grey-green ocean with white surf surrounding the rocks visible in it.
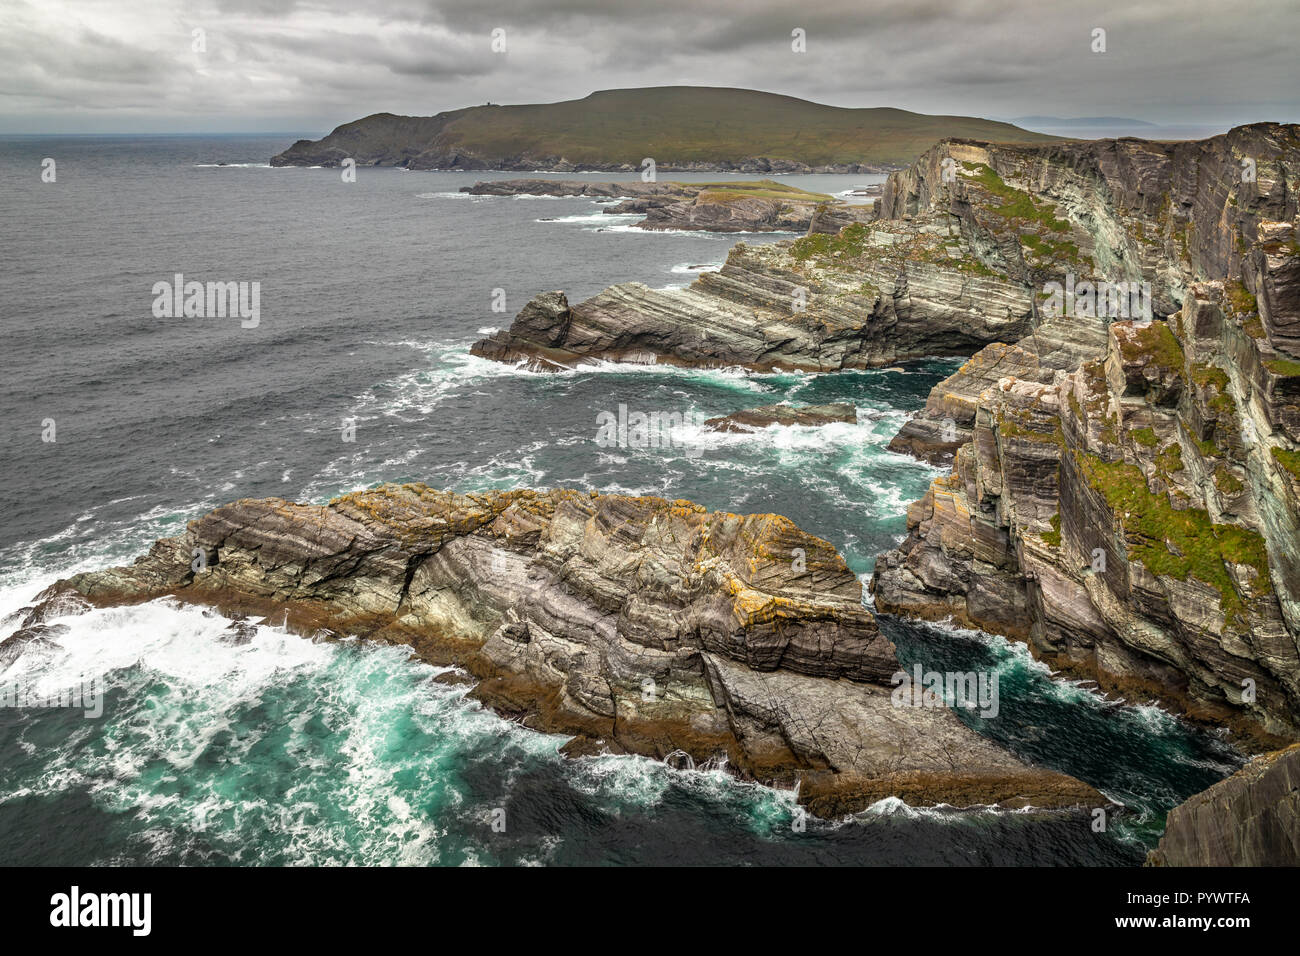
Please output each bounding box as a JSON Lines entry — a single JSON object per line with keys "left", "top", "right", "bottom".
{"left": 0, "top": 134, "right": 1243, "bottom": 865}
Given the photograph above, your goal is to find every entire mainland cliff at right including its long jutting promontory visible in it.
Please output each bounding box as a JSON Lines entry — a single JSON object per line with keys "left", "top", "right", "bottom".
{"left": 475, "top": 124, "right": 1300, "bottom": 764}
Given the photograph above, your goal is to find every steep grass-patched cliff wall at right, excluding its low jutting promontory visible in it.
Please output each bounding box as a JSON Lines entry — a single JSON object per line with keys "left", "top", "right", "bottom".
{"left": 872, "top": 124, "right": 1300, "bottom": 740}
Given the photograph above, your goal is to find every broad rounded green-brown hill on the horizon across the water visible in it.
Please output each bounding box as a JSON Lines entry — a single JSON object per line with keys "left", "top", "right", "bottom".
{"left": 272, "top": 86, "right": 1053, "bottom": 173}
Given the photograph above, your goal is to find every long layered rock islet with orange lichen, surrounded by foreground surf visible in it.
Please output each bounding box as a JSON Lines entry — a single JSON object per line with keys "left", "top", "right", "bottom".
{"left": 15, "top": 485, "right": 1105, "bottom": 813}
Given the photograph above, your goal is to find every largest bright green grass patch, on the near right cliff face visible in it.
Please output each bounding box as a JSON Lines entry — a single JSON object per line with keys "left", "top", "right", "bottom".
{"left": 1076, "top": 453, "right": 1270, "bottom": 626}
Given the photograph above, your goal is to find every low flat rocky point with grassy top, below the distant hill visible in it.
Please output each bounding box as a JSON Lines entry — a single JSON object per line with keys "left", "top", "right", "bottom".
{"left": 460, "top": 179, "right": 871, "bottom": 233}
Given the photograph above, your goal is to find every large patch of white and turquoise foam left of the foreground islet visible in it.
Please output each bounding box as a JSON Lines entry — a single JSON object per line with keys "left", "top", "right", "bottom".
{"left": 0, "top": 600, "right": 574, "bottom": 864}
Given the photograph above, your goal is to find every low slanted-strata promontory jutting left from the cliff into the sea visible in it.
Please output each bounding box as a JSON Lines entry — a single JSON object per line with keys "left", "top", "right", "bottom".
{"left": 472, "top": 220, "right": 1034, "bottom": 372}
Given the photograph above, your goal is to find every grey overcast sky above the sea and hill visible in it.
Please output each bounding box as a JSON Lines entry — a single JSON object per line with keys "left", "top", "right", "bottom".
{"left": 0, "top": 0, "right": 1300, "bottom": 135}
